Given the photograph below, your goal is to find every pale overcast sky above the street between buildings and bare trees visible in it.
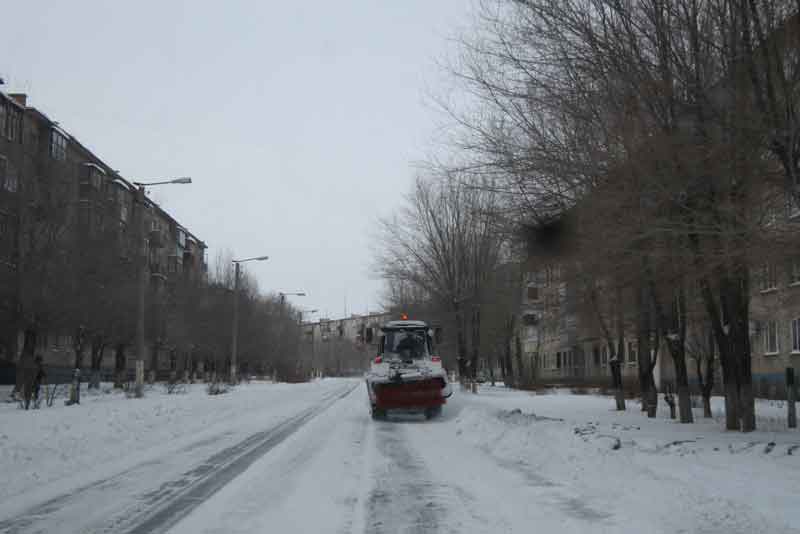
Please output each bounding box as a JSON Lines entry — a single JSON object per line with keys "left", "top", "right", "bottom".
{"left": 0, "top": 0, "right": 469, "bottom": 317}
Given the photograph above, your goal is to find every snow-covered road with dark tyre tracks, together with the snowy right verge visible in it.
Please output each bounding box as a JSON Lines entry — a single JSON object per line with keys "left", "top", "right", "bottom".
{"left": 0, "top": 380, "right": 800, "bottom": 534}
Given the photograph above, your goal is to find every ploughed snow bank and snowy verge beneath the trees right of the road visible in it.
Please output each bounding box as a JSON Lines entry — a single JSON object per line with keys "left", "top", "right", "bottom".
{"left": 454, "top": 387, "right": 800, "bottom": 532}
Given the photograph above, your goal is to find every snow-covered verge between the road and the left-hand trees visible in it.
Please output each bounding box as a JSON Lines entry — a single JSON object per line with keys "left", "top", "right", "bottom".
{"left": 0, "top": 380, "right": 350, "bottom": 515}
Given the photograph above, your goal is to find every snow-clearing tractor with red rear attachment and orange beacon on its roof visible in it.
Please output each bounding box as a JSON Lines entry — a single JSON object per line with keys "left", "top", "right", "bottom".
{"left": 366, "top": 321, "right": 452, "bottom": 419}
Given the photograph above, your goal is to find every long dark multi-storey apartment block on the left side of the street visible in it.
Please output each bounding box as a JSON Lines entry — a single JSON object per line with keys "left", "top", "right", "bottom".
{"left": 0, "top": 92, "right": 206, "bottom": 381}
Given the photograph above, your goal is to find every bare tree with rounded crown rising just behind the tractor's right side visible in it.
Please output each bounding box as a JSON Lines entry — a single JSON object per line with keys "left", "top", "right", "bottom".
{"left": 376, "top": 175, "right": 504, "bottom": 384}
